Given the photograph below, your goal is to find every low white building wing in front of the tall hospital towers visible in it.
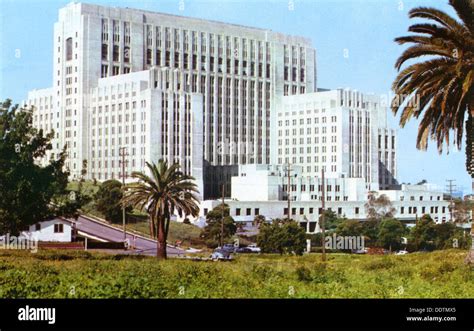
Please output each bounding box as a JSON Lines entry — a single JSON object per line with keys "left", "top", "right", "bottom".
{"left": 199, "top": 165, "right": 449, "bottom": 233}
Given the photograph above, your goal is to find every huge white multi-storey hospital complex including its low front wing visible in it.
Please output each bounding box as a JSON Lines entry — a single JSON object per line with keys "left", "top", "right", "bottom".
{"left": 26, "top": 3, "right": 447, "bottom": 231}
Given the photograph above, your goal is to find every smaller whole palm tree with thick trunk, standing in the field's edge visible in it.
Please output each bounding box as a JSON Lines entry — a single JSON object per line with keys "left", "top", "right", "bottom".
{"left": 122, "top": 160, "right": 199, "bottom": 259}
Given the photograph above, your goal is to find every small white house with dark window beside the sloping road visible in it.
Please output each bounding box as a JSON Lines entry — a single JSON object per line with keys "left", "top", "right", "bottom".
{"left": 22, "top": 218, "right": 73, "bottom": 242}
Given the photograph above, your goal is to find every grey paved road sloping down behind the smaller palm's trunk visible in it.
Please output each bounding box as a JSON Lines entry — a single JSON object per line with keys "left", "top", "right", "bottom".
{"left": 75, "top": 216, "right": 185, "bottom": 257}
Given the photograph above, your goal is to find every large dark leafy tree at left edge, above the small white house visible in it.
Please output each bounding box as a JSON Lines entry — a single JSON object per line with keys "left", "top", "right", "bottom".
{"left": 0, "top": 99, "right": 85, "bottom": 235}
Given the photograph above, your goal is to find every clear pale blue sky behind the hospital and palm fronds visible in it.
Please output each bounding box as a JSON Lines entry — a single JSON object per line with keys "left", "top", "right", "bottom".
{"left": 0, "top": 0, "right": 471, "bottom": 193}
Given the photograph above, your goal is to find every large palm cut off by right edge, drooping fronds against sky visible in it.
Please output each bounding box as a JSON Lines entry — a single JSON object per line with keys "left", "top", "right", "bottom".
{"left": 391, "top": 0, "right": 474, "bottom": 178}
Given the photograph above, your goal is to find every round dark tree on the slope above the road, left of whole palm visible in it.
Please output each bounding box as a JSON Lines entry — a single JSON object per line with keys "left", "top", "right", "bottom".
{"left": 94, "top": 179, "right": 132, "bottom": 223}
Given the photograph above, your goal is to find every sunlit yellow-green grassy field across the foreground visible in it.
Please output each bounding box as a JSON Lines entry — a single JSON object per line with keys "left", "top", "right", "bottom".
{"left": 0, "top": 250, "right": 474, "bottom": 298}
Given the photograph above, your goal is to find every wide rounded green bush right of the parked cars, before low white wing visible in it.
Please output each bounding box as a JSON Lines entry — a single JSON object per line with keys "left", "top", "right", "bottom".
{"left": 257, "top": 219, "right": 306, "bottom": 255}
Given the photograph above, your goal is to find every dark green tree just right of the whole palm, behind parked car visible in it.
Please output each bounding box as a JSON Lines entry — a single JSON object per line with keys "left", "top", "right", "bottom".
{"left": 201, "top": 204, "right": 237, "bottom": 247}
